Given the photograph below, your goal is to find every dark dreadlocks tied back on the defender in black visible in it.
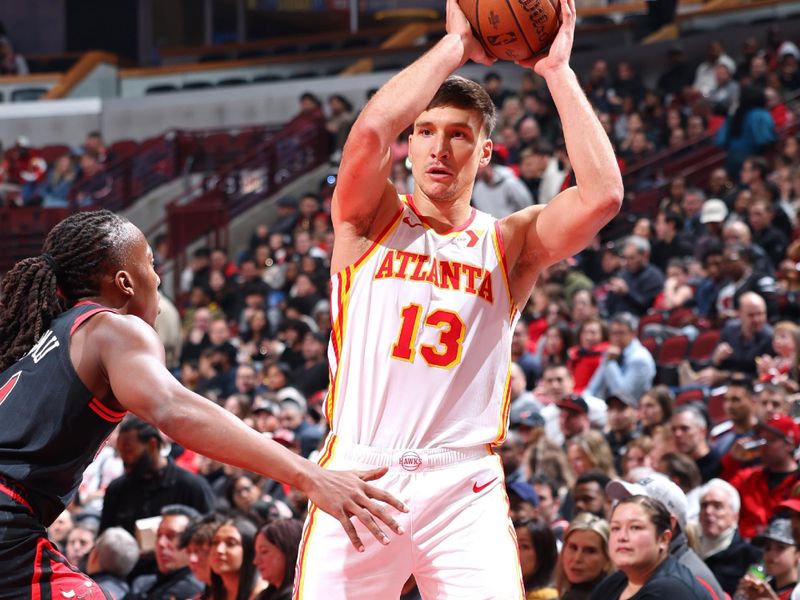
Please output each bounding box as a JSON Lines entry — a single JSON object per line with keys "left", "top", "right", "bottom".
{"left": 0, "top": 210, "right": 130, "bottom": 371}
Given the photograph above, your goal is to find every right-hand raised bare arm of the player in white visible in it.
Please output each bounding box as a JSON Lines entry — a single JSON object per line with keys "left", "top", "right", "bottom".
{"left": 504, "top": 0, "right": 623, "bottom": 304}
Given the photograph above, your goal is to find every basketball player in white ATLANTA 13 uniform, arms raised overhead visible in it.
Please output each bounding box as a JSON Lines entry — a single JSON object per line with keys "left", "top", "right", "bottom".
{"left": 295, "top": 0, "right": 622, "bottom": 600}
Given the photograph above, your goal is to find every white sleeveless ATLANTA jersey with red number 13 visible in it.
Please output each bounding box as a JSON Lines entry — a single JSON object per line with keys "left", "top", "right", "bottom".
{"left": 325, "top": 196, "right": 519, "bottom": 448}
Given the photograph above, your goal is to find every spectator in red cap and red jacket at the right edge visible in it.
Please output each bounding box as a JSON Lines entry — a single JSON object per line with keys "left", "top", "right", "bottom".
{"left": 725, "top": 415, "right": 800, "bottom": 539}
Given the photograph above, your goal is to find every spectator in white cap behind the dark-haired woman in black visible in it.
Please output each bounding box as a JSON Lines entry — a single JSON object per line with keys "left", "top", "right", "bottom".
{"left": 606, "top": 473, "right": 725, "bottom": 600}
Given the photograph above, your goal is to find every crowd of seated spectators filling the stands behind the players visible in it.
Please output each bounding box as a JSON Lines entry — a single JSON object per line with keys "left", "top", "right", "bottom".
{"left": 7, "top": 25, "right": 800, "bottom": 600}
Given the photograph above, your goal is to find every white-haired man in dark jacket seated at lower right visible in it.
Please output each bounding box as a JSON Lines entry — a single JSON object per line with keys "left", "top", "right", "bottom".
{"left": 698, "top": 479, "right": 763, "bottom": 596}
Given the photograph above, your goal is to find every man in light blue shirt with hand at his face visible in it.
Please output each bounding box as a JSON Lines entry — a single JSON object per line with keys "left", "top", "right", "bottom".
{"left": 586, "top": 313, "right": 656, "bottom": 398}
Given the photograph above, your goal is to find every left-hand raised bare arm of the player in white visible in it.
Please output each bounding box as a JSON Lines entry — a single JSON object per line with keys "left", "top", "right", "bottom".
{"left": 332, "top": 0, "right": 492, "bottom": 236}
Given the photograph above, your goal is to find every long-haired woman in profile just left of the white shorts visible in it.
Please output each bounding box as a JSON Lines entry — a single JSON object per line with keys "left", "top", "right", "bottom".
{"left": 255, "top": 519, "right": 303, "bottom": 600}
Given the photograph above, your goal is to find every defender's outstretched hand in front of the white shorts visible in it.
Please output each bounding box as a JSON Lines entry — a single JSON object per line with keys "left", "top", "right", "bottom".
{"left": 308, "top": 467, "right": 408, "bottom": 552}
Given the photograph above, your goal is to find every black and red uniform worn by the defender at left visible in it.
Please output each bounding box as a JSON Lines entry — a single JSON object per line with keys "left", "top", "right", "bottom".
{"left": 0, "top": 302, "right": 125, "bottom": 600}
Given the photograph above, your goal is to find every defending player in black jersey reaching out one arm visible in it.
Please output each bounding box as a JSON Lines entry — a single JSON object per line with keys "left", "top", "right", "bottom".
{"left": 0, "top": 211, "right": 404, "bottom": 600}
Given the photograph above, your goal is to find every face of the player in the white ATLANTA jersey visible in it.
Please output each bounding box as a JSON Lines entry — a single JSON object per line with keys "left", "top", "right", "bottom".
{"left": 408, "top": 106, "right": 492, "bottom": 202}
